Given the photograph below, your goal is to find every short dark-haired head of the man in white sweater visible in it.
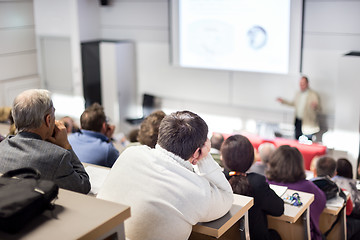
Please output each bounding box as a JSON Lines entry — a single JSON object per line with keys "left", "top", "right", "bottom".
{"left": 158, "top": 111, "right": 208, "bottom": 160}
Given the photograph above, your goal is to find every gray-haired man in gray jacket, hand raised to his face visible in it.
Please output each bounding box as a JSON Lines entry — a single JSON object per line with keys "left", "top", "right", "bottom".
{"left": 0, "top": 89, "right": 90, "bottom": 193}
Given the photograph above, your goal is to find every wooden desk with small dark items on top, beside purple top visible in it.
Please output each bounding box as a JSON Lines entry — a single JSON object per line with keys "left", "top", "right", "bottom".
{"left": 268, "top": 189, "right": 314, "bottom": 239}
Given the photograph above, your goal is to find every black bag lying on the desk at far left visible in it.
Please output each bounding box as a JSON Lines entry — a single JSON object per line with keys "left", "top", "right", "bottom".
{"left": 0, "top": 168, "right": 59, "bottom": 233}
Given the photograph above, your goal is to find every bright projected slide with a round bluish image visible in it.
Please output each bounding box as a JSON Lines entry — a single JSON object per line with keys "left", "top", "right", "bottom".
{"left": 178, "top": 0, "right": 290, "bottom": 74}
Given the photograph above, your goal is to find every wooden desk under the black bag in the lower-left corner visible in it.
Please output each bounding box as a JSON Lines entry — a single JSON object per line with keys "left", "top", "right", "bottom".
{"left": 0, "top": 189, "right": 130, "bottom": 240}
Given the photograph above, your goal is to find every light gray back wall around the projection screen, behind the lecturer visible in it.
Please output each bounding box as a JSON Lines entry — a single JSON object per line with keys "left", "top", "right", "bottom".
{"left": 100, "top": 0, "right": 360, "bottom": 133}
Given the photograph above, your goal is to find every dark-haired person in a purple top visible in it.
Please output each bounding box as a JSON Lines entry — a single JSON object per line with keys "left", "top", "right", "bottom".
{"left": 265, "top": 145, "right": 326, "bottom": 240}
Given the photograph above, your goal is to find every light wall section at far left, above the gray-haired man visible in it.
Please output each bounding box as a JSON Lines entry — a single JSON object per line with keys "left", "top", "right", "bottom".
{"left": 0, "top": 0, "right": 40, "bottom": 106}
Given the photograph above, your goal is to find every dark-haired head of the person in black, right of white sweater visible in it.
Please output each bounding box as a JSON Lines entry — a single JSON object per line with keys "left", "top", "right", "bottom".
{"left": 221, "top": 135, "right": 254, "bottom": 173}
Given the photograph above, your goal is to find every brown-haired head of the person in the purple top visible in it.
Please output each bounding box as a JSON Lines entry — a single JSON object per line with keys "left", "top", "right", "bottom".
{"left": 266, "top": 145, "right": 306, "bottom": 183}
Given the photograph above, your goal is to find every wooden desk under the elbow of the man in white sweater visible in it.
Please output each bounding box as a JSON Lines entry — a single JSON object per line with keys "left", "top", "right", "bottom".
{"left": 189, "top": 194, "right": 254, "bottom": 240}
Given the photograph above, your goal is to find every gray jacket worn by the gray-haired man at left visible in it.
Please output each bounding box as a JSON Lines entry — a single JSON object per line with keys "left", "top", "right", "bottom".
{"left": 0, "top": 132, "right": 90, "bottom": 194}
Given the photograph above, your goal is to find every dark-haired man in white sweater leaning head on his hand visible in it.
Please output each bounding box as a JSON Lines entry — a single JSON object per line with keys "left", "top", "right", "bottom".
{"left": 97, "top": 111, "right": 233, "bottom": 240}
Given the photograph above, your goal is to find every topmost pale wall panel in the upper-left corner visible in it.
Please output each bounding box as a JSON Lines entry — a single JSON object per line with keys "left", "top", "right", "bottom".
{"left": 0, "top": 1, "right": 34, "bottom": 28}
